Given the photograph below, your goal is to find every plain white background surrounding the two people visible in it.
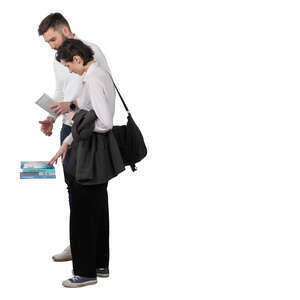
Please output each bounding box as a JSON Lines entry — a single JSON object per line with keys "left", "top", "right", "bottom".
{"left": 0, "top": 0, "right": 300, "bottom": 300}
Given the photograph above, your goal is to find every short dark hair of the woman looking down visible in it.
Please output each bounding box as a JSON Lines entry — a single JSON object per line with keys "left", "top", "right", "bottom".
{"left": 56, "top": 39, "right": 94, "bottom": 66}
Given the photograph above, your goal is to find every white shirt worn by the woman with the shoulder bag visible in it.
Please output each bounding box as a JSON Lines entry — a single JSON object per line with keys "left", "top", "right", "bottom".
{"left": 64, "top": 62, "right": 116, "bottom": 145}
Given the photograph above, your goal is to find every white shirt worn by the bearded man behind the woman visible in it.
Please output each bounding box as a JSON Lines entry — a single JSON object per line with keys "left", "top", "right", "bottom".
{"left": 50, "top": 35, "right": 110, "bottom": 125}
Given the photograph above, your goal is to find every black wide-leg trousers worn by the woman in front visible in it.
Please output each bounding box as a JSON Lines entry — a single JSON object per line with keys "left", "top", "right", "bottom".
{"left": 69, "top": 176, "right": 109, "bottom": 277}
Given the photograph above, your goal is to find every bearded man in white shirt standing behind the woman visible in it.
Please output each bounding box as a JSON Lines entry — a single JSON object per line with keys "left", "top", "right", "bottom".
{"left": 38, "top": 13, "right": 110, "bottom": 268}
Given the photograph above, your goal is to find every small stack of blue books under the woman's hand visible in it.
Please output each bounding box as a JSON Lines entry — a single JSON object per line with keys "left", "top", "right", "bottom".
{"left": 20, "top": 161, "right": 56, "bottom": 179}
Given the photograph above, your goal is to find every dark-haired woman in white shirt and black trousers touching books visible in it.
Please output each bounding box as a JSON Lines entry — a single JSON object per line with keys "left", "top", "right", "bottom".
{"left": 49, "top": 39, "right": 125, "bottom": 287}
